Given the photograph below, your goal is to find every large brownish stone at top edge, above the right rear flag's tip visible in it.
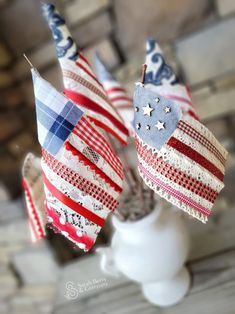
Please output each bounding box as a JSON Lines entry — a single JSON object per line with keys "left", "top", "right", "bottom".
{"left": 114, "top": 0, "right": 214, "bottom": 55}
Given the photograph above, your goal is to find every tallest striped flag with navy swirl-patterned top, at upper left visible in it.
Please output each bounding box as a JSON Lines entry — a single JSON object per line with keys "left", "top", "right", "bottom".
{"left": 42, "top": 4, "right": 128, "bottom": 144}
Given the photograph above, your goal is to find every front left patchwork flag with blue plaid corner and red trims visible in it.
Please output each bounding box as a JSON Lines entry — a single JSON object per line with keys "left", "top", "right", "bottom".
{"left": 32, "top": 69, "right": 123, "bottom": 251}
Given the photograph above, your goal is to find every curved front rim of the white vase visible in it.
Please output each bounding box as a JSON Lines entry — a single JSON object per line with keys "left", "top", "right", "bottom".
{"left": 112, "top": 203, "right": 162, "bottom": 230}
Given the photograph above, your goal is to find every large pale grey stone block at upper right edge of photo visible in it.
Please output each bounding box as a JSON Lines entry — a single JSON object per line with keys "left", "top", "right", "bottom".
{"left": 176, "top": 18, "right": 235, "bottom": 84}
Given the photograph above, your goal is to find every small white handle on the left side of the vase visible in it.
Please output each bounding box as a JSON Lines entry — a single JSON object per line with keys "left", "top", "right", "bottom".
{"left": 96, "top": 247, "right": 120, "bottom": 277}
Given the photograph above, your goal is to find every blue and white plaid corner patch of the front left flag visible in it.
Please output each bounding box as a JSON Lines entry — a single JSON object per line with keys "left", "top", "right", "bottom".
{"left": 32, "top": 69, "right": 83, "bottom": 155}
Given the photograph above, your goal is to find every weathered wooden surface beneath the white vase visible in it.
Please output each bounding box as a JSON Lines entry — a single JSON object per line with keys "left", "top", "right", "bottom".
{"left": 54, "top": 175, "right": 235, "bottom": 314}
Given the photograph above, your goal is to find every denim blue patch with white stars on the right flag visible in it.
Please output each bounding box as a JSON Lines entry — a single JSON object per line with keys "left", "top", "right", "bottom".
{"left": 134, "top": 85, "right": 182, "bottom": 150}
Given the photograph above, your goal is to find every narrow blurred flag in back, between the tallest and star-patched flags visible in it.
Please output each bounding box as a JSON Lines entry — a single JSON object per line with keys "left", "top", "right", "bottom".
{"left": 95, "top": 54, "right": 134, "bottom": 134}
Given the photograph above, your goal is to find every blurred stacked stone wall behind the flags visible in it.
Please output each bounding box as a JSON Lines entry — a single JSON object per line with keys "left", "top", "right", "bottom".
{"left": 0, "top": 0, "right": 235, "bottom": 314}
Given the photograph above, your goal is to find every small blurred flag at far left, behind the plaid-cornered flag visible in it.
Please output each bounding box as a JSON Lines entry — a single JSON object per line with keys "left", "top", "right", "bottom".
{"left": 22, "top": 153, "right": 46, "bottom": 242}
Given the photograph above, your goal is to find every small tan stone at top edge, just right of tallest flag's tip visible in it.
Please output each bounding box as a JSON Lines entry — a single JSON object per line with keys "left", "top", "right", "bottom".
{"left": 65, "top": 0, "right": 109, "bottom": 24}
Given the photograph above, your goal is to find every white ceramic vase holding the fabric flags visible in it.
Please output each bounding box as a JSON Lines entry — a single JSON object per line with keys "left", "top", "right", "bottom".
{"left": 97, "top": 201, "right": 190, "bottom": 307}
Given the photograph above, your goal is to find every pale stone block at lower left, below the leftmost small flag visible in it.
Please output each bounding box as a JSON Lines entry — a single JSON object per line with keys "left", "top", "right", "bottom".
{"left": 12, "top": 241, "right": 59, "bottom": 285}
